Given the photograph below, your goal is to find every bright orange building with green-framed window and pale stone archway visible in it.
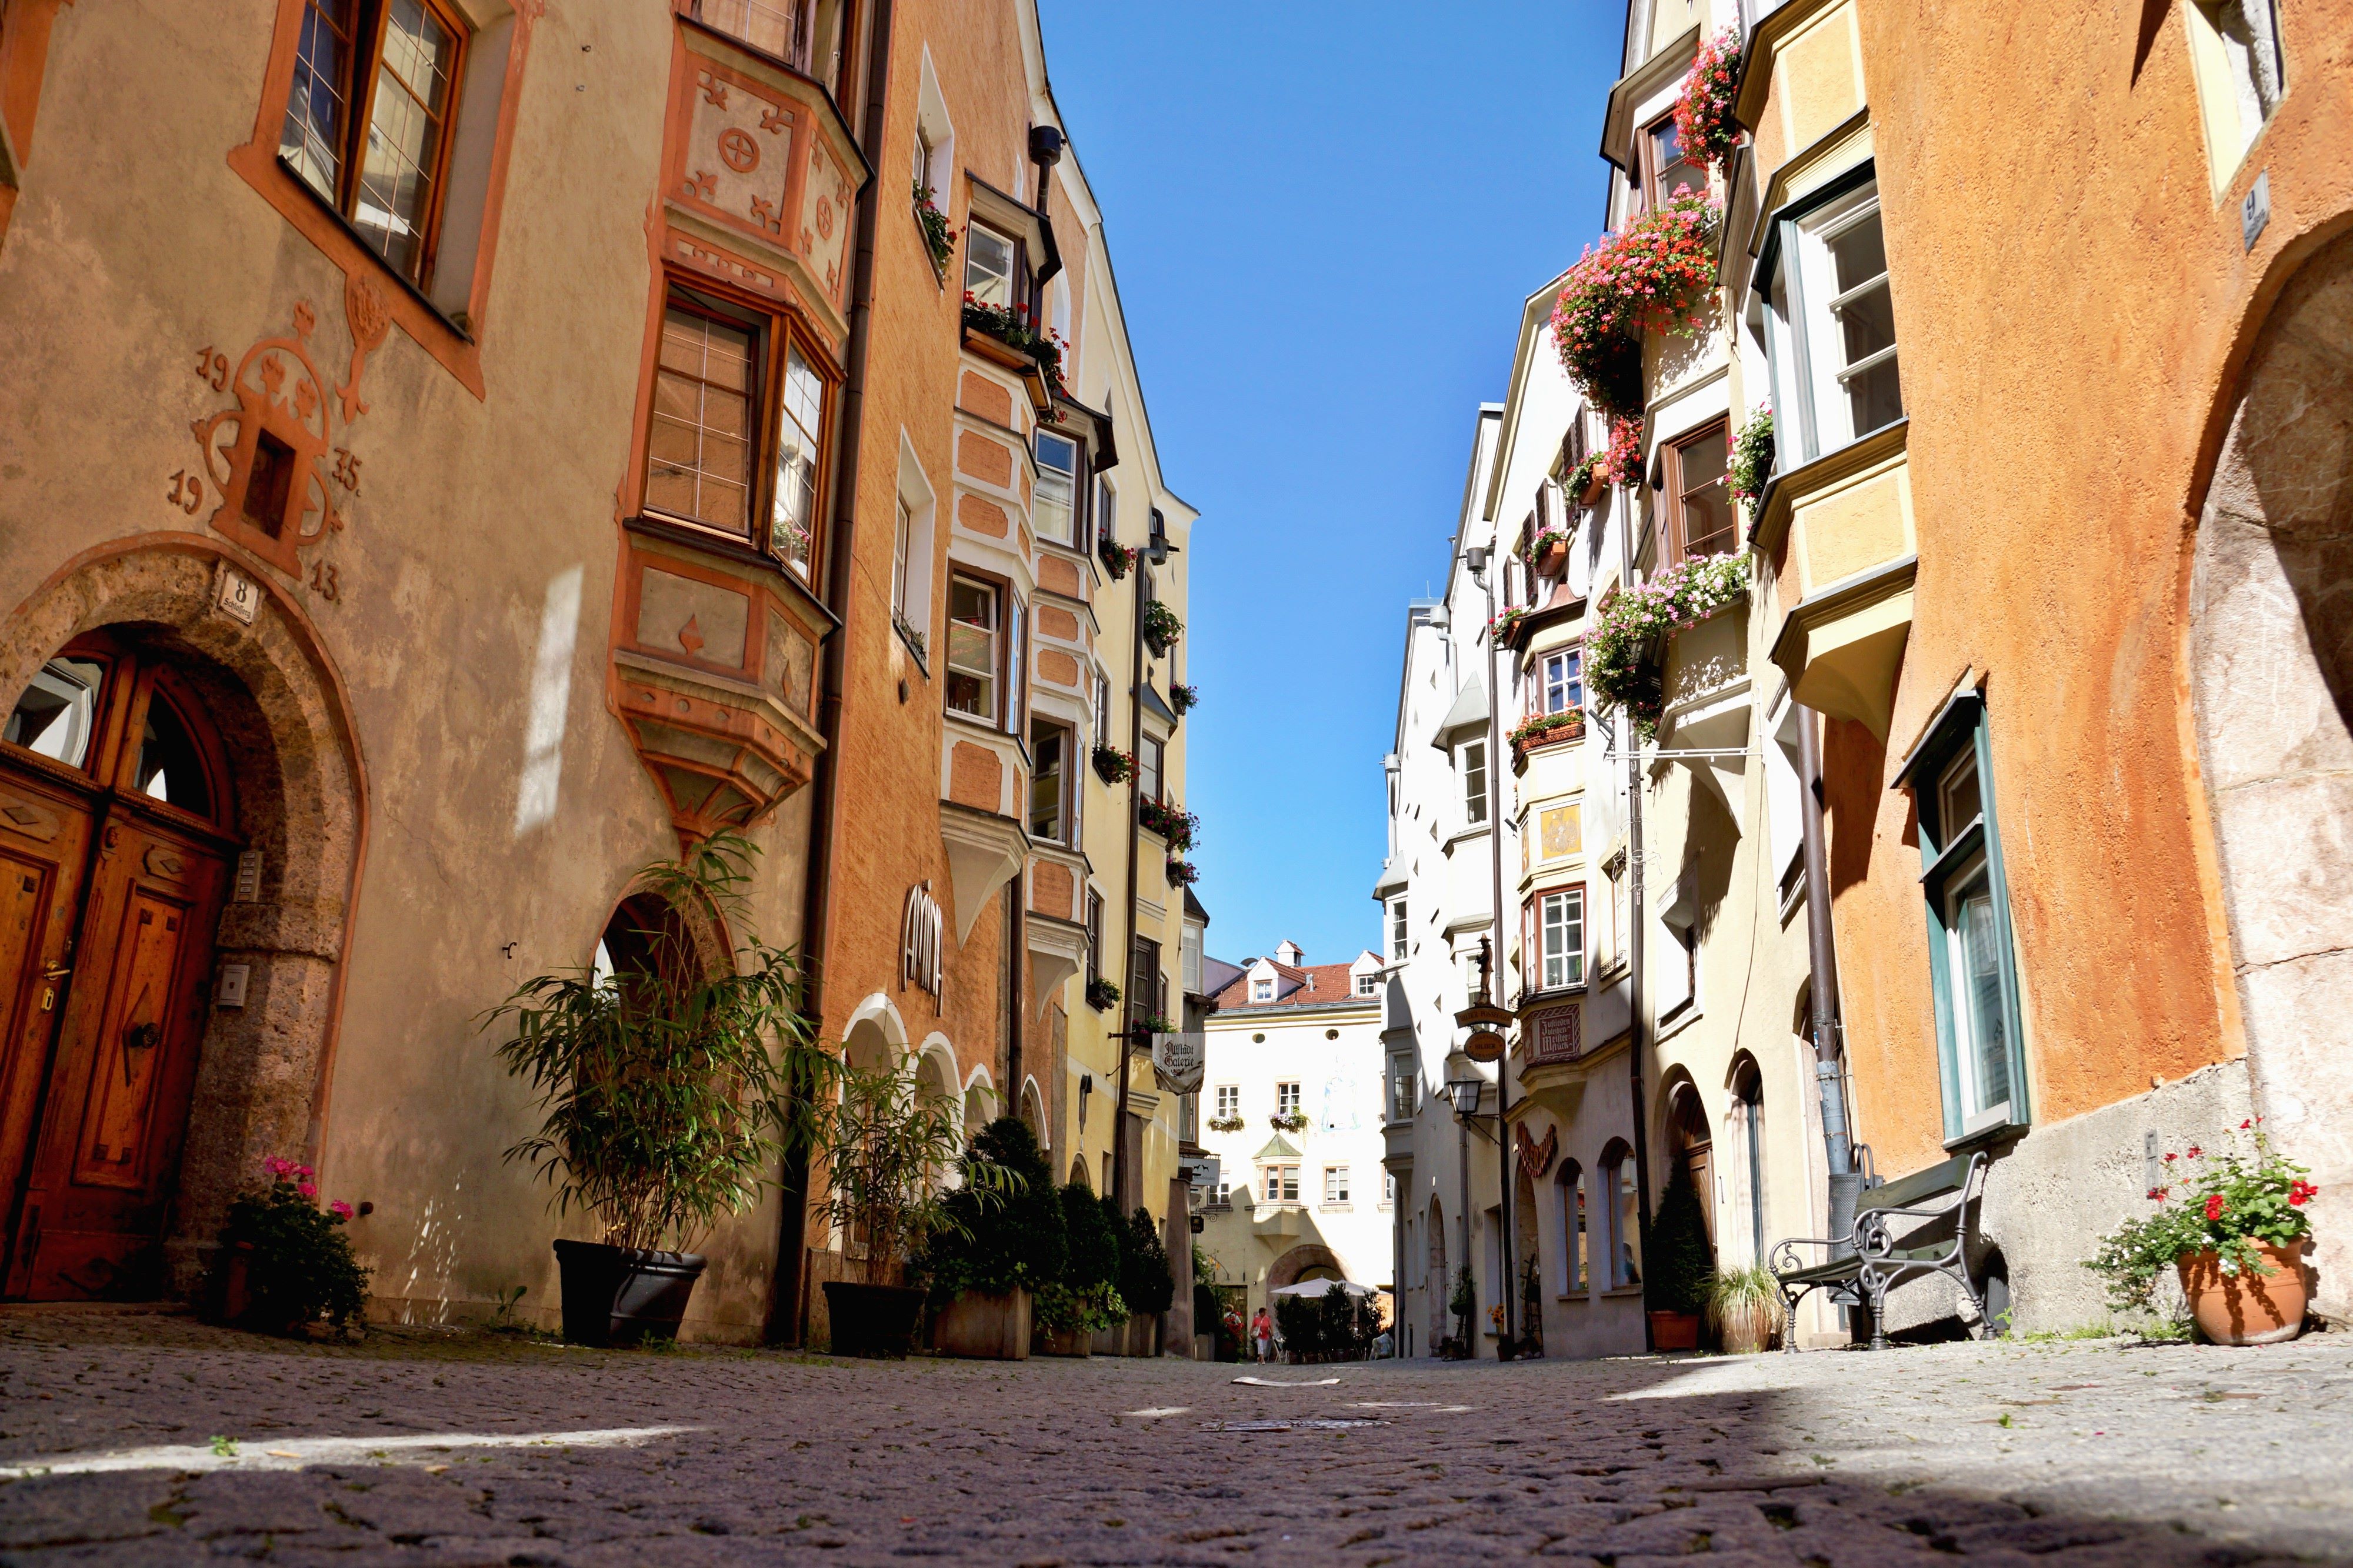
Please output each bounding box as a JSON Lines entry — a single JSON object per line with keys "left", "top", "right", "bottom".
{"left": 1725, "top": 0, "right": 2353, "bottom": 1326}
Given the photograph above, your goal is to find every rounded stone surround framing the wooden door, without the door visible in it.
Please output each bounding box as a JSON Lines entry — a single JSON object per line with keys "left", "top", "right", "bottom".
{"left": 0, "top": 535, "right": 367, "bottom": 1293}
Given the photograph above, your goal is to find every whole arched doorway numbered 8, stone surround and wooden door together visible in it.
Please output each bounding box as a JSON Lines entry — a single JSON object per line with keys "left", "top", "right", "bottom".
{"left": 0, "top": 537, "right": 367, "bottom": 1300}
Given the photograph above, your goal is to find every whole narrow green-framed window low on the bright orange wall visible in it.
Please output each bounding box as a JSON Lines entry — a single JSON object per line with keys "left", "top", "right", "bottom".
{"left": 1897, "top": 692, "right": 2028, "bottom": 1142}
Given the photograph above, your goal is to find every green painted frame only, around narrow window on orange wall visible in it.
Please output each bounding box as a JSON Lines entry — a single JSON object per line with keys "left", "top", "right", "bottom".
{"left": 1897, "top": 692, "right": 2033, "bottom": 1149}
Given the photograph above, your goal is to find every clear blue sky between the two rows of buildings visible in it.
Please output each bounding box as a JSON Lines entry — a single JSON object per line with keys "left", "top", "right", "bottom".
{"left": 1040, "top": 0, "right": 1626, "bottom": 963}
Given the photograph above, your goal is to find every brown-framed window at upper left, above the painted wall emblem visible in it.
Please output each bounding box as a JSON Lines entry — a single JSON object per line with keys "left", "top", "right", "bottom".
{"left": 278, "top": 0, "right": 466, "bottom": 287}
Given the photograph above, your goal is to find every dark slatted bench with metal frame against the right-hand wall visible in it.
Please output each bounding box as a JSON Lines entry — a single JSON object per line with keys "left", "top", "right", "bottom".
{"left": 1767, "top": 1151, "right": 1988, "bottom": 1352}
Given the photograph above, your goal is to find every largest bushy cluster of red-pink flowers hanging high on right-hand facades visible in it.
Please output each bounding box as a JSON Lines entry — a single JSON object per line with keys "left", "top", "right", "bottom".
{"left": 1553, "top": 195, "right": 1722, "bottom": 417}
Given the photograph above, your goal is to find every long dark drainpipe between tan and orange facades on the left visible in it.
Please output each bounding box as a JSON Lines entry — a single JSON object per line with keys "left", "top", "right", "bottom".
{"left": 767, "top": 0, "right": 892, "bottom": 1345}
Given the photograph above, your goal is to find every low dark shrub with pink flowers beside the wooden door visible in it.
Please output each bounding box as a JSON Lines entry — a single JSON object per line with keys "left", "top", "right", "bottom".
{"left": 205, "top": 1156, "right": 367, "bottom": 1335}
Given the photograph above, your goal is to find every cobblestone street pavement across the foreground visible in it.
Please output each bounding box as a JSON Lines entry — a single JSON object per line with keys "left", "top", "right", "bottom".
{"left": 0, "top": 1312, "right": 2353, "bottom": 1568}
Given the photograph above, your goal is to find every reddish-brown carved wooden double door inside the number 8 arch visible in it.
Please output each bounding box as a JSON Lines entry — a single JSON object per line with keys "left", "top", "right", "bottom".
{"left": 0, "top": 643, "right": 233, "bottom": 1300}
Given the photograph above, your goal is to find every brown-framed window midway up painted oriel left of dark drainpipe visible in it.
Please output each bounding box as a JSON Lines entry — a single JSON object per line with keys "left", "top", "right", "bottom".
{"left": 645, "top": 287, "right": 826, "bottom": 579}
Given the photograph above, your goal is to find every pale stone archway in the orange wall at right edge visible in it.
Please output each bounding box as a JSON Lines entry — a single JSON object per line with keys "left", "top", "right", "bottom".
{"left": 2188, "top": 235, "right": 2353, "bottom": 1316}
